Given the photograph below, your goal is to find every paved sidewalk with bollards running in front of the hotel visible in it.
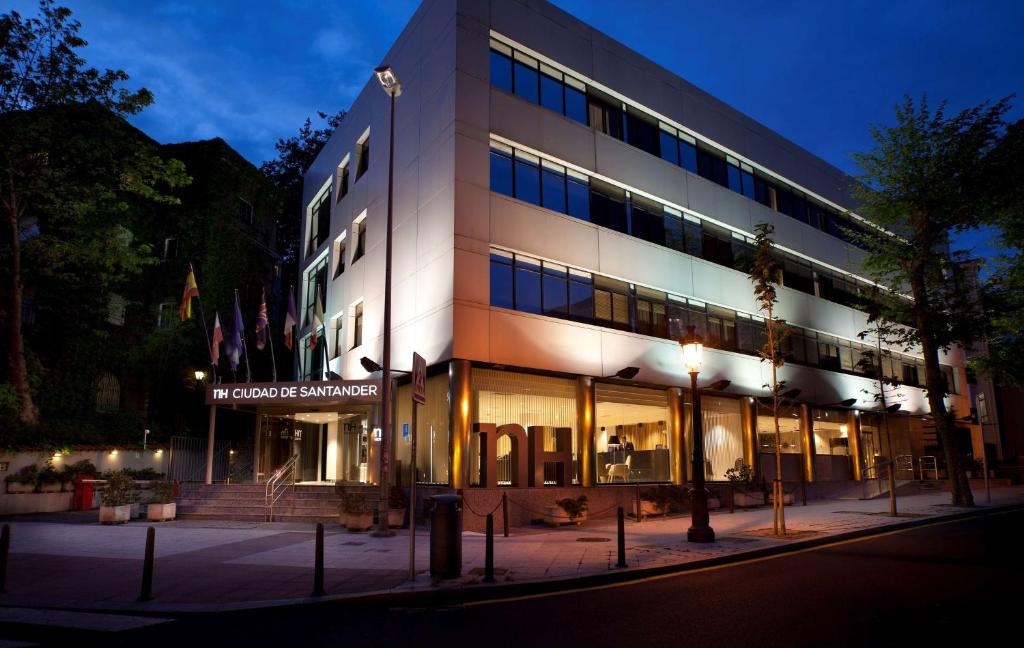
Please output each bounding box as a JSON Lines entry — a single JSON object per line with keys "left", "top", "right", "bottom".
{"left": 0, "top": 487, "right": 1024, "bottom": 612}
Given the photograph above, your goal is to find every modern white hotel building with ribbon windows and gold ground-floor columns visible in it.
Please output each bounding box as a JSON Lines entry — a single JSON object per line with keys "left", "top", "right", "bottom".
{"left": 256, "top": 0, "right": 970, "bottom": 495}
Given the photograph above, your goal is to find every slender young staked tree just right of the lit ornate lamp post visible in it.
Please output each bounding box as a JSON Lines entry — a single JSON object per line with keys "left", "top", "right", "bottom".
{"left": 748, "top": 223, "right": 790, "bottom": 535}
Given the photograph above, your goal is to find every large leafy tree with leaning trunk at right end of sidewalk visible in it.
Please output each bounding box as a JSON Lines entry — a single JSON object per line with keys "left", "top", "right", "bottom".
{"left": 854, "top": 97, "right": 1009, "bottom": 506}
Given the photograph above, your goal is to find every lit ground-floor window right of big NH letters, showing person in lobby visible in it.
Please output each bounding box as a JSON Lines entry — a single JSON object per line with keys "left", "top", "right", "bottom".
{"left": 594, "top": 383, "right": 672, "bottom": 483}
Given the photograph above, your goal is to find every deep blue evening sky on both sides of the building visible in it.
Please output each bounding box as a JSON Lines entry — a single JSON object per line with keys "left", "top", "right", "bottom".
{"left": 9, "top": 0, "right": 1024, "bottom": 253}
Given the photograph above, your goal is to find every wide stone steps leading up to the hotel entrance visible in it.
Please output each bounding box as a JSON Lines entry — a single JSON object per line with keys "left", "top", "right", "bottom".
{"left": 177, "top": 483, "right": 380, "bottom": 522}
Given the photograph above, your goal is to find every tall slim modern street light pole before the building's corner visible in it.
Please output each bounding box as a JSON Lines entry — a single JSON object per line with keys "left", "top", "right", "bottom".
{"left": 373, "top": 66, "right": 401, "bottom": 537}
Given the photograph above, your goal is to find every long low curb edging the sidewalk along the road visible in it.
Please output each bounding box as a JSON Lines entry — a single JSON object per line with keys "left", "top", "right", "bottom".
{"left": 0, "top": 503, "right": 1024, "bottom": 616}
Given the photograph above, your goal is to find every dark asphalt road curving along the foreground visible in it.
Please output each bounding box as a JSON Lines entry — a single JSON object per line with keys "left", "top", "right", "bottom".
{"left": 0, "top": 510, "right": 1024, "bottom": 648}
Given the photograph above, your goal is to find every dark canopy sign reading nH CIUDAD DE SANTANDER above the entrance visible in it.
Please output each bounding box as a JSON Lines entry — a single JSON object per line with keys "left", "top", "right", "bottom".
{"left": 206, "top": 380, "right": 381, "bottom": 405}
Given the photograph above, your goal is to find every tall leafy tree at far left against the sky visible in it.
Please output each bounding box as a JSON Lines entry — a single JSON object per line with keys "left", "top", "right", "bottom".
{"left": 0, "top": 0, "right": 187, "bottom": 425}
